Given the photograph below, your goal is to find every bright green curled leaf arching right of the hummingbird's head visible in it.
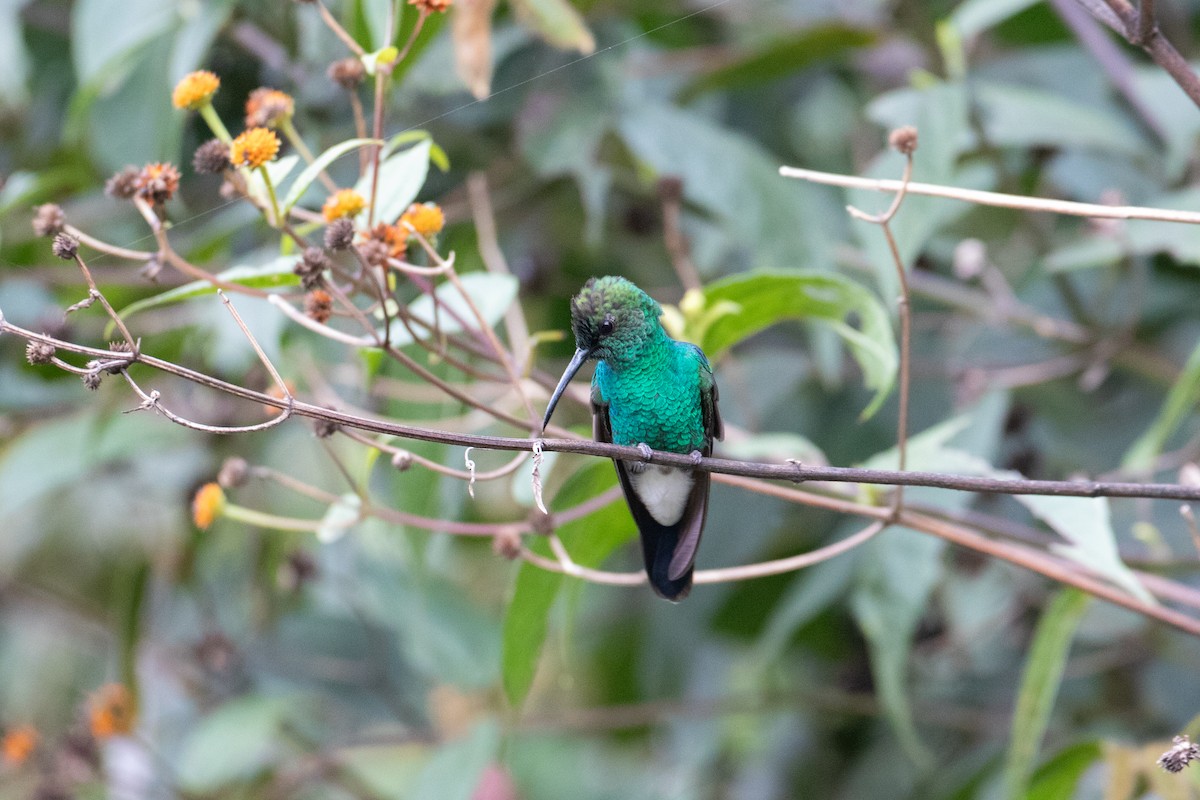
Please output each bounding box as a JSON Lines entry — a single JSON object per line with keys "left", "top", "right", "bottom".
{"left": 701, "top": 271, "right": 899, "bottom": 419}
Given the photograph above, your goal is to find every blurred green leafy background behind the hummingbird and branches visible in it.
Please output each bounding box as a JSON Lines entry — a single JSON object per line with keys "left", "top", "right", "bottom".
{"left": 0, "top": 0, "right": 1200, "bottom": 800}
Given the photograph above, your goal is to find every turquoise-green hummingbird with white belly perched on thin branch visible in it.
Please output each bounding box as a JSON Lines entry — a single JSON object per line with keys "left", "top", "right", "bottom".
{"left": 542, "top": 276, "right": 722, "bottom": 602}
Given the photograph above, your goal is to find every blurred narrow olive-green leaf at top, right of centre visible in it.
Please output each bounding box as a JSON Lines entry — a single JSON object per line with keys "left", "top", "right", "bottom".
{"left": 679, "top": 23, "right": 877, "bottom": 99}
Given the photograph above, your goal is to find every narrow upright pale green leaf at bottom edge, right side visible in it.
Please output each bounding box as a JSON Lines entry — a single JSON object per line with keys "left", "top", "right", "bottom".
{"left": 1004, "top": 589, "right": 1090, "bottom": 800}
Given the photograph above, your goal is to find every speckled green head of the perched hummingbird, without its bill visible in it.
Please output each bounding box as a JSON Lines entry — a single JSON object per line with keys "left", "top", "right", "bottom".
{"left": 571, "top": 275, "right": 662, "bottom": 361}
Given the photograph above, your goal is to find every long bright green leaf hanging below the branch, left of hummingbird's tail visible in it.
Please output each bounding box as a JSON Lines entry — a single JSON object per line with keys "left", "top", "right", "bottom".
{"left": 502, "top": 462, "right": 637, "bottom": 708}
